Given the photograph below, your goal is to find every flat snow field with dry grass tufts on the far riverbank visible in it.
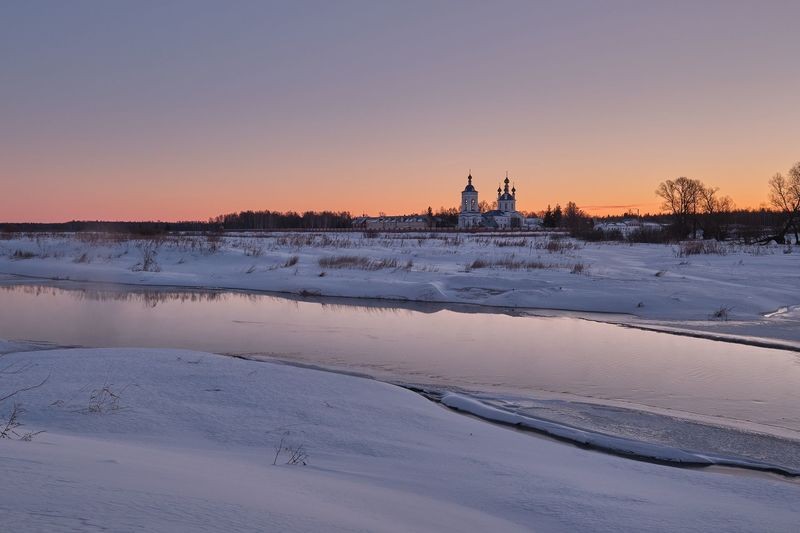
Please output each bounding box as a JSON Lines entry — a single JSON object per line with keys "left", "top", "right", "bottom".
{"left": 0, "top": 233, "right": 800, "bottom": 340}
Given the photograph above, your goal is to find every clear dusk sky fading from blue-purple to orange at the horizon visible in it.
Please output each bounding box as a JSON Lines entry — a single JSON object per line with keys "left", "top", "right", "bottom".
{"left": 0, "top": 0, "right": 800, "bottom": 222}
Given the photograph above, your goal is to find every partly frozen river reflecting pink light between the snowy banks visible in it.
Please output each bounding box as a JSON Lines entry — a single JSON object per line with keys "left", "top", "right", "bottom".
{"left": 0, "top": 279, "right": 800, "bottom": 468}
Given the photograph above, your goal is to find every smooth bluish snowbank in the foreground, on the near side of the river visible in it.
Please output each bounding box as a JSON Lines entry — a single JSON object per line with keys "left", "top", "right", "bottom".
{"left": 0, "top": 348, "right": 800, "bottom": 531}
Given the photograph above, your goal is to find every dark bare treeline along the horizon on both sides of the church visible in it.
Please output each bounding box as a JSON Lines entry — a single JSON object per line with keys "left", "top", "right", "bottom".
{"left": 0, "top": 163, "right": 800, "bottom": 239}
